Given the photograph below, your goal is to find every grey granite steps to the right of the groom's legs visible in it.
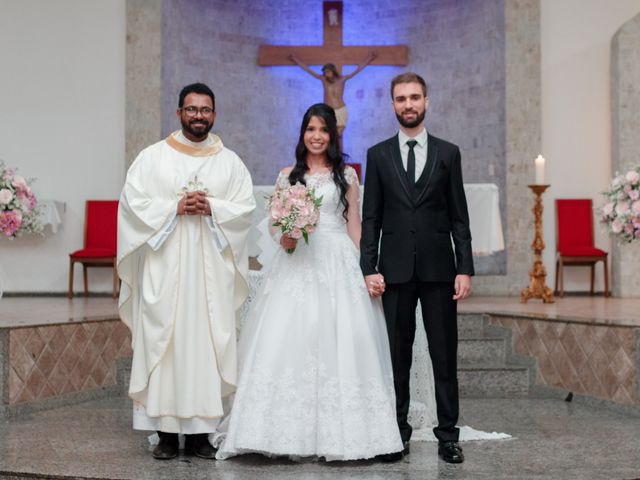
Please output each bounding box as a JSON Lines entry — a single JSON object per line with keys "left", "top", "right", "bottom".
{"left": 458, "top": 314, "right": 534, "bottom": 398}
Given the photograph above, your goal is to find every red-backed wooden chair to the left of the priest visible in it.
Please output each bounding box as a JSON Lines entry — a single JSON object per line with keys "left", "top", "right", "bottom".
{"left": 69, "top": 200, "right": 119, "bottom": 298}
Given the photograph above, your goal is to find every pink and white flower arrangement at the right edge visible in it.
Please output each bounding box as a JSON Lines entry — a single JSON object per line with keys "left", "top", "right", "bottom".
{"left": 600, "top": 167, "right": 640, "bottom": 243}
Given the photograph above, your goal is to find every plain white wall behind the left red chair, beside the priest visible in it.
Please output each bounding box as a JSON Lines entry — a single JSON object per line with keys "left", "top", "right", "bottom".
{"left": 0, "top": 0, "right": 126, "bottom": 292}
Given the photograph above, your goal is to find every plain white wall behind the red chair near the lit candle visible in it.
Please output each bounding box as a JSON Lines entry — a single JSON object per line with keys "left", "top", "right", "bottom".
{"left": 532, "top": 0, "right": 640, "bottom": 296}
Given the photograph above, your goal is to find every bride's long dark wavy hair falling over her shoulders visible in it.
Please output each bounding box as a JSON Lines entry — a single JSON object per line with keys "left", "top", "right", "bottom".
{"left": 289, "top": 103, "right": 349, "bottom": 220}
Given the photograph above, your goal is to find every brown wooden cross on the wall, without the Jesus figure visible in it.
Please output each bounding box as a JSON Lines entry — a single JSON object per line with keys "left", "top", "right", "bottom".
{"left": 258, "top": 1, "right": 408, "bottom": 74}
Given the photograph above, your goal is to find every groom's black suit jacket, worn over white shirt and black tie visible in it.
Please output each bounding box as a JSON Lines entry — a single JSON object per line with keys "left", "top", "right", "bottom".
{"left": 360, "top": 131, "right": 474, "bottom": 283}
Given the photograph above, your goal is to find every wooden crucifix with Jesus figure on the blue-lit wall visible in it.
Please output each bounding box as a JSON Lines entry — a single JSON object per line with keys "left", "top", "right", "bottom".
{"left": 258, "top": 1, "right": 408, "bottom": 174}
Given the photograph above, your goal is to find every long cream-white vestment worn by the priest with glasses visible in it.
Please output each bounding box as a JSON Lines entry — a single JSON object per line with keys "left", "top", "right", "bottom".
{"left": 118, "top": 132, "right": 255, "bottom": 434}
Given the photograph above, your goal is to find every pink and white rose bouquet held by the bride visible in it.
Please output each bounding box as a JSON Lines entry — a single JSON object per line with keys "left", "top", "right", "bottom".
{"left": 267, "top": 183, "right": 322, "bottom": 253}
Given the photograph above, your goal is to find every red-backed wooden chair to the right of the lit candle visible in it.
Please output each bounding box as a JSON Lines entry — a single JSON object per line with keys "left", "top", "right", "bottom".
{"left": 556, "top": 199, "right": 609, "bottom": 297}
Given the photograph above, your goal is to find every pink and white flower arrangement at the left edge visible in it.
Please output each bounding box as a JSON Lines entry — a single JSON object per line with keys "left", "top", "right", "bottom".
{"left": 0, "top": 161, "right": 43, "bottom": 238}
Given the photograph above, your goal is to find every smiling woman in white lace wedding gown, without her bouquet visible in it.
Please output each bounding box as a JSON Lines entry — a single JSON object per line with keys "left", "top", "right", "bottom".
{"left": 217, "top": 103, "right": 403, "bottom": 461}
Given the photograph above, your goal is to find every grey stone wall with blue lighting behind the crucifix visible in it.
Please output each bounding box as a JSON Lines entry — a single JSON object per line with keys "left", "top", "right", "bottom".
{"left": 162, "top": 0, "right": 506, "bottom": 273}
